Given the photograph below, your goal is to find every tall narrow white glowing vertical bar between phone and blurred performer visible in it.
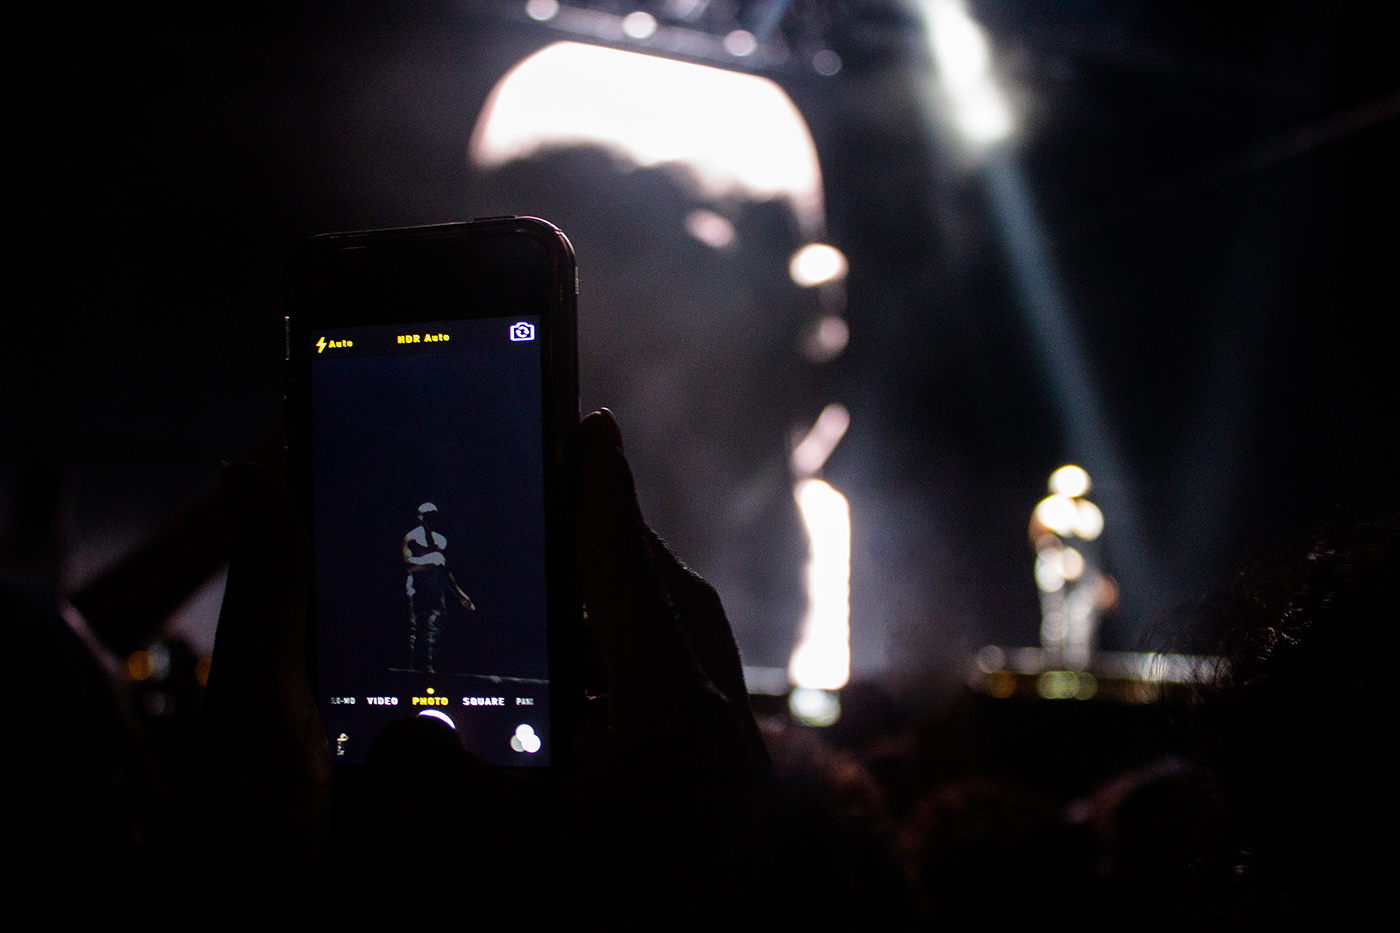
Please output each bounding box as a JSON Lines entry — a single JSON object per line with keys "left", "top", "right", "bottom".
{"left": 788, "top": 479, "right": 851, "bottom": 689}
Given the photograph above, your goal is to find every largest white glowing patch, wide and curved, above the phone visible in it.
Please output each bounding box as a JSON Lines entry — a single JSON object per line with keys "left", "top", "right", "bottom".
{"left": 468, "top": 36, "right": 825, "bottom": 237}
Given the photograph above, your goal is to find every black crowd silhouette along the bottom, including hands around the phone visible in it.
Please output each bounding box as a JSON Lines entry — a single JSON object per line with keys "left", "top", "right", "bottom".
{"left": 0, "top": 413, "right": 1400, "bottom": 930}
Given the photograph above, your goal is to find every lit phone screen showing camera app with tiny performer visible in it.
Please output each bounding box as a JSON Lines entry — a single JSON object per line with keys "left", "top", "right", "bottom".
{"left": 309, "top": 315, "right": 550, "bottom": 766}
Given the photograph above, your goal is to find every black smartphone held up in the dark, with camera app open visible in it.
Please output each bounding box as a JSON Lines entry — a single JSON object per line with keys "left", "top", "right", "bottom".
{"left": 286, "top": 217, "right": 582, "bottom": 769}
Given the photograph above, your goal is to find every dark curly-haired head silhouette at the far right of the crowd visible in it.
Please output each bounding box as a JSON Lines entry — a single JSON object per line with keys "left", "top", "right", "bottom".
{"left": 1201, "top": 516, "right": 1400, "bottom": 919}
